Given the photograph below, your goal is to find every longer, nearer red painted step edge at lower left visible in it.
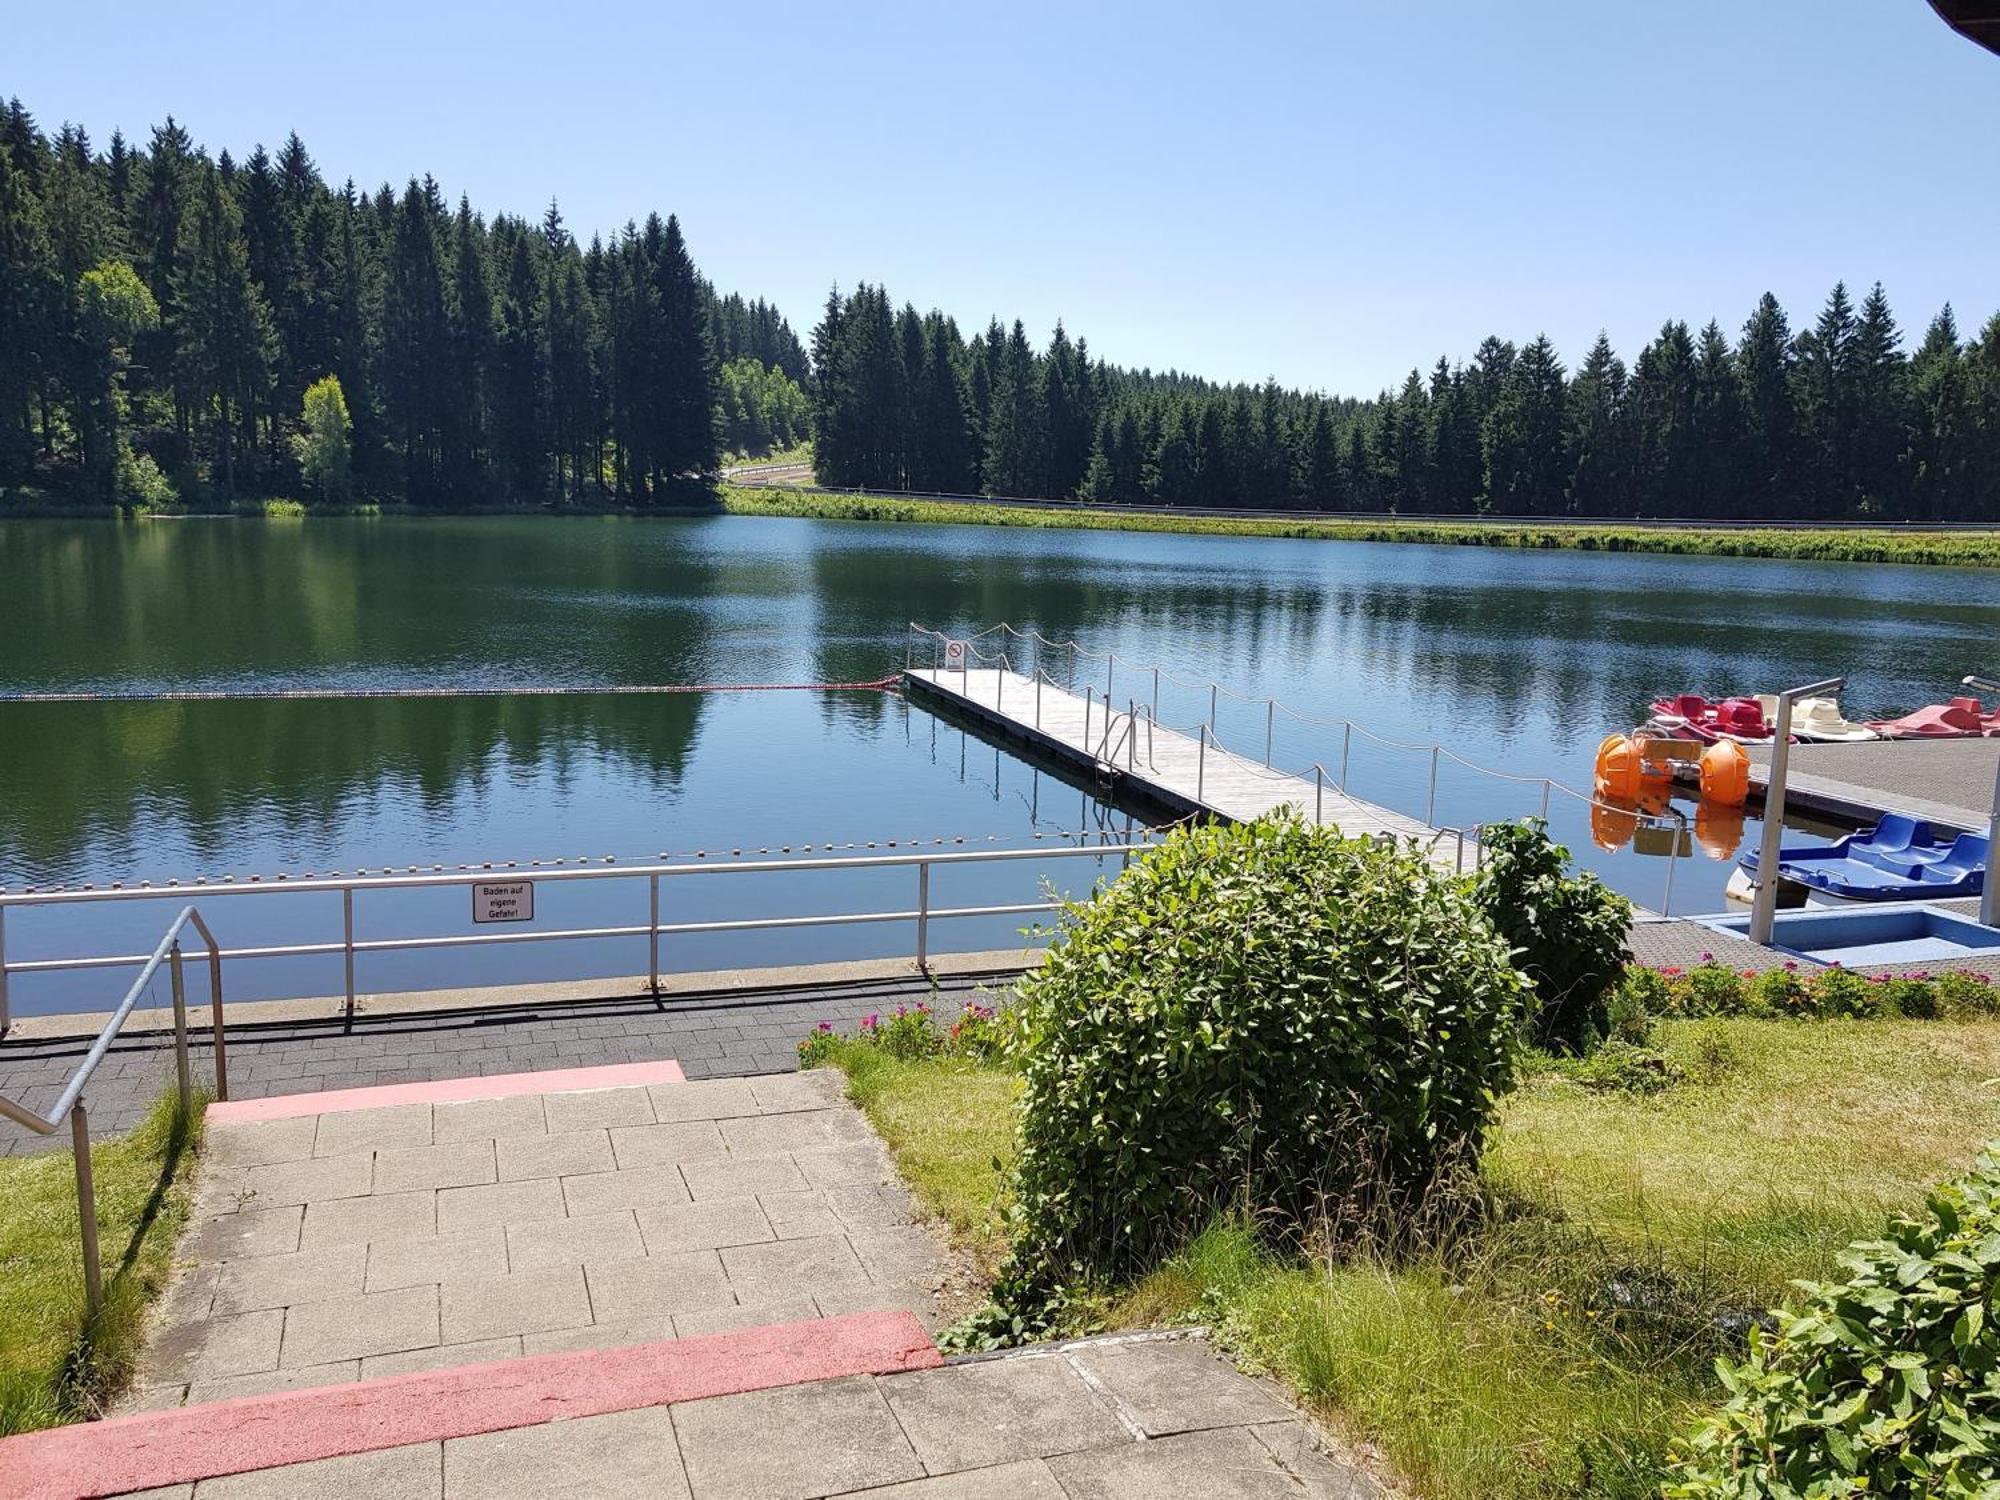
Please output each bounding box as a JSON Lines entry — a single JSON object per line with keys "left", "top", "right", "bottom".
{"left": 0, "top": 1312, "right": 944, "bottom": 1500}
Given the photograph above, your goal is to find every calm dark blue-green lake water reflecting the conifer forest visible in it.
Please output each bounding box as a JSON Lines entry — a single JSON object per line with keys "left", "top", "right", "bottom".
{"left": 0, "top": 518, "right": 2000, "bottom": 1012}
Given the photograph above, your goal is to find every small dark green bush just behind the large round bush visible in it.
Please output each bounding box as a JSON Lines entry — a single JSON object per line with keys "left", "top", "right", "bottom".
{"left": 1472, "top": 818, "right": 1632, "bottom": 1052}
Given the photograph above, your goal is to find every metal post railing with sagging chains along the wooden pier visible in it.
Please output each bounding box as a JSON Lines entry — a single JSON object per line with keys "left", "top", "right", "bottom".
{"left": 904, "top": 620, "right": 1688, "bottom": 916}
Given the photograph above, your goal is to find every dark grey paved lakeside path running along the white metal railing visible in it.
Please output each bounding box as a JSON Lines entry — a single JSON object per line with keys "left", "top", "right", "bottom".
{"left": 0, "top": 978, "right": 996, "bottom": 1156}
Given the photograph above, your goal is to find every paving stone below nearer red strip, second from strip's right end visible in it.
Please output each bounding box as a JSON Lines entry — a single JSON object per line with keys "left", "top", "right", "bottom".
{"left": 670, "top": 1376, "right": 924, "bottom": 1500}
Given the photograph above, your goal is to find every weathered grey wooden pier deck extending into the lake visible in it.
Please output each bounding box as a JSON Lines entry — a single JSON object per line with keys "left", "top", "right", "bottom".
{"left": 904, "top": 666, "right": 1474, "bottom": 868}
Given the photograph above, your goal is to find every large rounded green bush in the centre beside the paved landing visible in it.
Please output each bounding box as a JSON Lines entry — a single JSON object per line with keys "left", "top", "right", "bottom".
{"left": 1000, "top": 816, "right": 1526, "bottom": 1306}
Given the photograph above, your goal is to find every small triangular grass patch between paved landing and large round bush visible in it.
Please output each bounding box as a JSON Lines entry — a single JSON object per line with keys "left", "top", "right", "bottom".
{"left": 804, "top": 1042, "right": 1020, "bottom": 1276}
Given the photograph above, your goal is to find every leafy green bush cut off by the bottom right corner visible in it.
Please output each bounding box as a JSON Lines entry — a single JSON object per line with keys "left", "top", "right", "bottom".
{"left": 1666, "top": 1142, "right": 2000, "bottom": 1500}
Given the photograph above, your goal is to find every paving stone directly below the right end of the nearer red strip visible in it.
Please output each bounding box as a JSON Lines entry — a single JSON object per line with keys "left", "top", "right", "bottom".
{"left": 878, "top": 1356, "right": 1132, "bottom": 1474}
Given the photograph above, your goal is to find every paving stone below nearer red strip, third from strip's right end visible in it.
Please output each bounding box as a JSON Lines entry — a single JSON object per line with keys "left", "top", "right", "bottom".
{"left": 444, "top": 1406, "right": 688, "bottom": 1500}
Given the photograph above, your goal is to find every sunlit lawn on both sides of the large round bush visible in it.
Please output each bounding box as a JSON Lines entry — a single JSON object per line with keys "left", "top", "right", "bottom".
{"left": 812, "top": 1020, "right": 2000, "bottom": 1500}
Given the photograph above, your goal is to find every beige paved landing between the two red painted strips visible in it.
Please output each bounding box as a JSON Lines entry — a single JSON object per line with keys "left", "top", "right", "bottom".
{"left": 126, "top": 1064, "right": 970, "bottom": 1410}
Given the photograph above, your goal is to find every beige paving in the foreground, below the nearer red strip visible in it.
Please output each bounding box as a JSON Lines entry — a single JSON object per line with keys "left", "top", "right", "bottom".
{"left": 97, "top": 1338, "right": 1378, "bottom": 1500}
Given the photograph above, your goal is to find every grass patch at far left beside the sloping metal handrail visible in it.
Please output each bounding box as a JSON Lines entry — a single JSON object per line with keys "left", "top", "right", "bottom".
{"left": 0, "top": 1096, "right": 200, "bottom": 1436}
